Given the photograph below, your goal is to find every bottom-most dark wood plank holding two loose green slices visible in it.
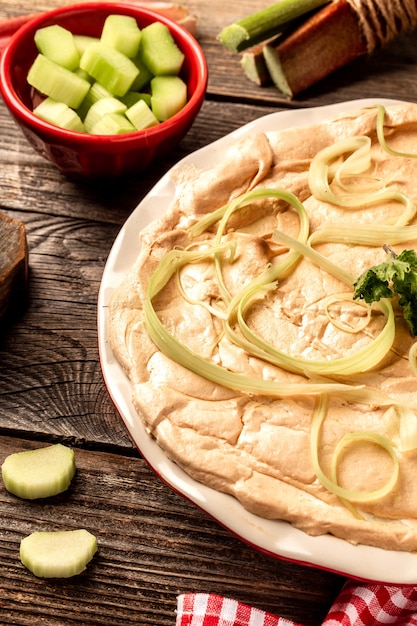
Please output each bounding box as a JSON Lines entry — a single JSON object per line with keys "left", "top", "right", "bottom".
{"left": 0, "top": 437, "right": 343, "bottom": 626}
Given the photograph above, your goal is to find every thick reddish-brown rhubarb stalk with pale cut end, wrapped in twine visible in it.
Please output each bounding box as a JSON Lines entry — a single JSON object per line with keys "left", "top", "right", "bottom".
{"left": 263, "top": 0, "right": 417, "bottom": 97}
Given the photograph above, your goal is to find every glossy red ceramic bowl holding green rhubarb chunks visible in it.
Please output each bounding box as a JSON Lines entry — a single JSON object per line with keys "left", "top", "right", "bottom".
{"left": 0, "top": 2, "right": 208, "bottom": 178}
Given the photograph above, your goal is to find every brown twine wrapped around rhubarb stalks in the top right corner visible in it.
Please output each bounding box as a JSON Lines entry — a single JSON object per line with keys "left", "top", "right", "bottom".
{"left": 347, "top": 0, "right": 417, "bottom": 53}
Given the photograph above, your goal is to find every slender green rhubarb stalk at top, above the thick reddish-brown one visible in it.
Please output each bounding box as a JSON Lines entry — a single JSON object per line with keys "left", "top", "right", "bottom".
{"left": 219, "top": 0, "right": 329, "bottom": 52}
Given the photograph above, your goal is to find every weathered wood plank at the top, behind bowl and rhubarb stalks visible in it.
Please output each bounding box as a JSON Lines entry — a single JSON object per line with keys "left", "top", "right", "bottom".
{"left": 1, "top": 0, "right": 417, "bottom": 107}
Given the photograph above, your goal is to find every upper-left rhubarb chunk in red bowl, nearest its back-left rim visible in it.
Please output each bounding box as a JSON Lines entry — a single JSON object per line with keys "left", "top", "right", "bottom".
{"left": 35, "top": 24, "right": 80, "bottom": 70}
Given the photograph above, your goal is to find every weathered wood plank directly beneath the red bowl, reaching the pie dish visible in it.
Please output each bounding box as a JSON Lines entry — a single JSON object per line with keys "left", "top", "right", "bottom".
{"left": 0, "top": 100, "right": 280, "bottom": 221}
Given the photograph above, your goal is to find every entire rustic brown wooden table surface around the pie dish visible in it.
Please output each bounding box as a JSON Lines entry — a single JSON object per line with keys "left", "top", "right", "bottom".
{"left": 0, "top": 0, "right": 417, "bottom": 626}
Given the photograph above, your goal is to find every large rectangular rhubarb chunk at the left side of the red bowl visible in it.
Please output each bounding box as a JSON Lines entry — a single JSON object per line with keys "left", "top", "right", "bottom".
{"left": 27, "top": 54, "right": 90, "bottom": 109}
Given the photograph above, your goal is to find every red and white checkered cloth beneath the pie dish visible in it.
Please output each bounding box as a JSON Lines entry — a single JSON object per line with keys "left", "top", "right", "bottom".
{"left": 176, "top": 581, "right": 417, "bottom": 626}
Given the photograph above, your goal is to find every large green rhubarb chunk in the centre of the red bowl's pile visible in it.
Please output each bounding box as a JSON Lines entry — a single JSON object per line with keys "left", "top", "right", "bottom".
{"left": 80, "top": 41, "right": 139, "bottom": 96}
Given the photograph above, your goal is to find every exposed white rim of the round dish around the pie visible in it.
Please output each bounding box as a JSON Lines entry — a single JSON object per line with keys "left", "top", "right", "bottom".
{"left": 98, "top": 99, "right": 417, "bottom": 583}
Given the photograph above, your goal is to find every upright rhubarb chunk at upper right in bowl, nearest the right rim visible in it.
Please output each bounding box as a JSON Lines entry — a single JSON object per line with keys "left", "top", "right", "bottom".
{"left": 140, "top": 22, "right": 184, "bottom": 76}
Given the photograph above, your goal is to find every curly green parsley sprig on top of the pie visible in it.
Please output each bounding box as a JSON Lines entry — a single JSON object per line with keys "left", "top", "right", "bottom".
{"left": 353, "top": 246, "right": 417, "bottom": 336}
